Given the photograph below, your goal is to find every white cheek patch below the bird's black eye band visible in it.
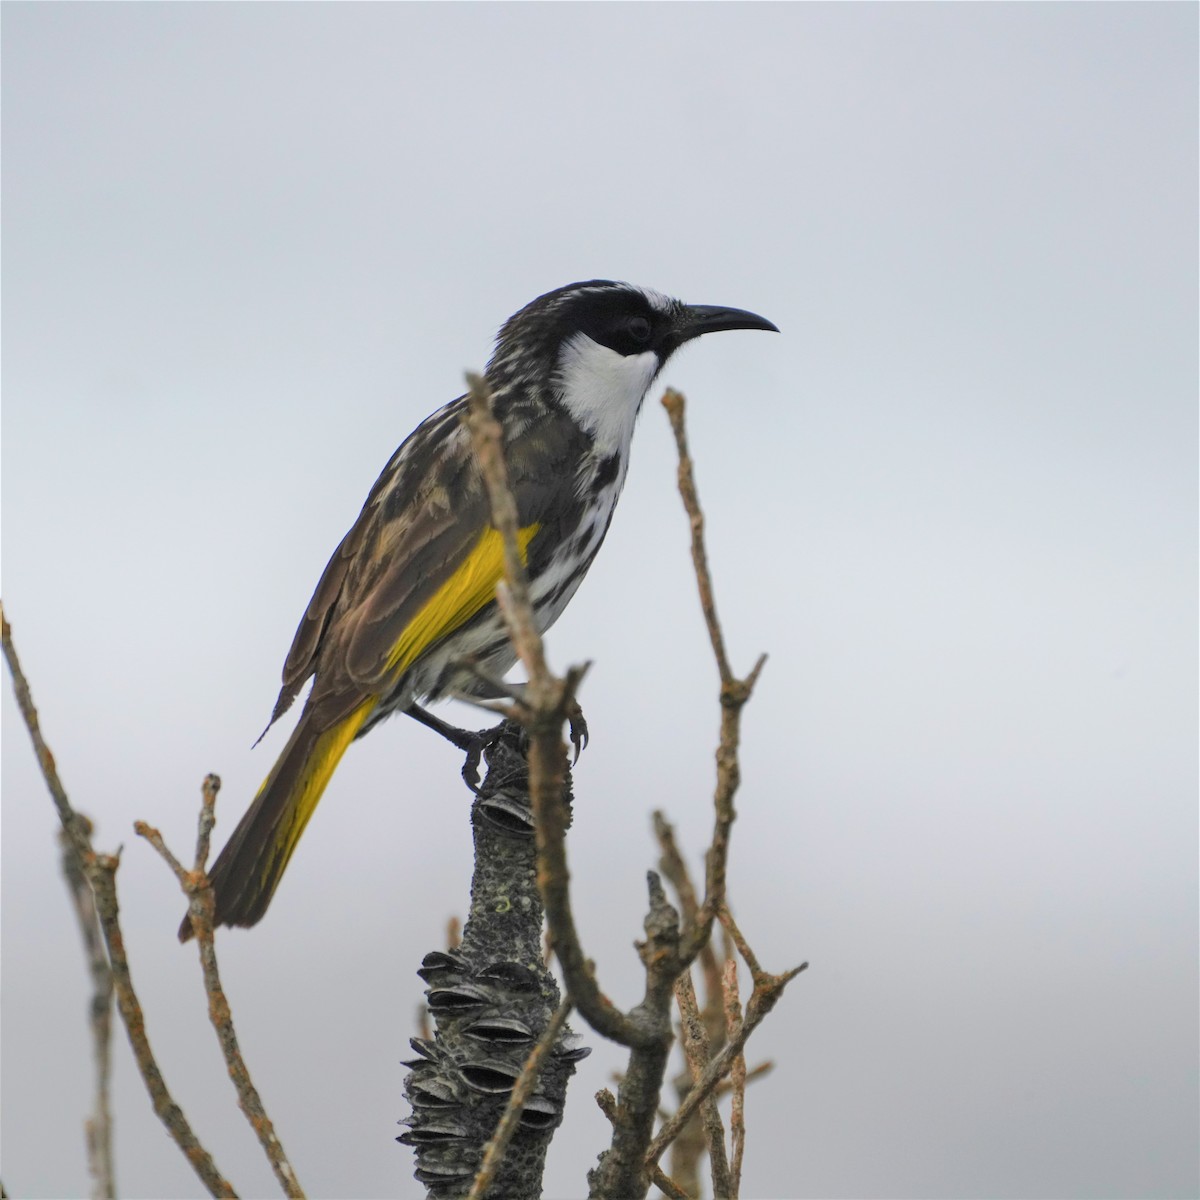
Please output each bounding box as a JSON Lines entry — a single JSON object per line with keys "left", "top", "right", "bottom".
{"left": 556, "top": 334, "right": 659, "bottom": 457}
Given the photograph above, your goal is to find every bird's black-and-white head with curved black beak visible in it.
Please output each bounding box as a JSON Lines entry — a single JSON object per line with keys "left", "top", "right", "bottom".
{"left": 487, "top": 280, "right": 779, "bottom": 450}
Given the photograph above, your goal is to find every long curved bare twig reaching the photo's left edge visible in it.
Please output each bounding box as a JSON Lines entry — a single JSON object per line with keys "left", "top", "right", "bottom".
{"left": 0, "top": 605, "right": 236, "bottom": 1196}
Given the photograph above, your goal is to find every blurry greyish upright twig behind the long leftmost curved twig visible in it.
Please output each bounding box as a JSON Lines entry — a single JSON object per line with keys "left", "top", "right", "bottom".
{"left": 59, "top": 812, "right": 116, "bottom": 1200}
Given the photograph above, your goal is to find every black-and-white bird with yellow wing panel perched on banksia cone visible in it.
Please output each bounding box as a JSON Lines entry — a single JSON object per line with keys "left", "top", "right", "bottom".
{"left": 179, "top": 280, "right": 779, "bottom": 942}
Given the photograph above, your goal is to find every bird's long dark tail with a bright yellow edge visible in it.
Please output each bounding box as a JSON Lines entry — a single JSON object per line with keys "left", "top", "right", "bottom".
{"left": 179, "top": 697, "right": 377, "bottom": 942}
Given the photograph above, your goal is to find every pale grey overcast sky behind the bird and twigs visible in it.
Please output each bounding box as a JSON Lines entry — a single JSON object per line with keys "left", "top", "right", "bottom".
{"left": 0, "top": 9, "right": 1200, "bottom": 1198}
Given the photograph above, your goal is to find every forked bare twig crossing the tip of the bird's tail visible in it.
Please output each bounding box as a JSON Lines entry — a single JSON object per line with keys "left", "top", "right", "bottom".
{"left": 133, "top": 806, "right": 304, "bottom": 1198}
